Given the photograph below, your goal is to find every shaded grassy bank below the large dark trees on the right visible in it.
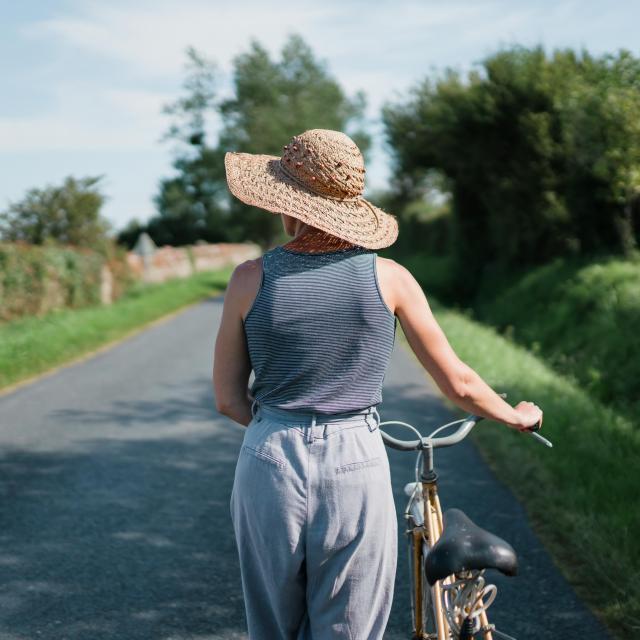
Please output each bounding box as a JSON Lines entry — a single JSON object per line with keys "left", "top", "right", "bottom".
{"left": 472, "top": 256, "right": 640, "bottom": 417}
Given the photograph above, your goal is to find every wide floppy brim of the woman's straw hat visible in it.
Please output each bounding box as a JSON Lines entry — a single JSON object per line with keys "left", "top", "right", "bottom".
{"left": 224, "top": 151, "right": 398, "bottom": 249}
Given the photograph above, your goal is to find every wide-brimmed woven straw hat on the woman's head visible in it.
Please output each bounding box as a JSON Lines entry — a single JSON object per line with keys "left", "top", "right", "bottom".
{"left": 224, "top": 129, "right": 398, "bottom": 249}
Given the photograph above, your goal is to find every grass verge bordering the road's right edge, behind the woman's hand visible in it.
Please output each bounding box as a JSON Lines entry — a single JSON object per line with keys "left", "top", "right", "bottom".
{"left": 400, "top": 300, "right": 640, "bottom": 638}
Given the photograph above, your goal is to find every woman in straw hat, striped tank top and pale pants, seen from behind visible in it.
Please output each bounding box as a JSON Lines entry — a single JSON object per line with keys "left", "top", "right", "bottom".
{"left": 214, "top": 129, "right": 542, "bottom": 640}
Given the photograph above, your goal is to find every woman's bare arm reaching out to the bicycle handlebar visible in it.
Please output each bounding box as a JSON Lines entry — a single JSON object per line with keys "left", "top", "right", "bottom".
{"left": 393, "top": 263, "right": 542, "bottom": 430}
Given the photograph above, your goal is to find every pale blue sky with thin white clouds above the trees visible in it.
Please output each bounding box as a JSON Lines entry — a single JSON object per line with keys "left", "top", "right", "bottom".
{"left": 0, "top": 0, "right": 640, "bottom": 229}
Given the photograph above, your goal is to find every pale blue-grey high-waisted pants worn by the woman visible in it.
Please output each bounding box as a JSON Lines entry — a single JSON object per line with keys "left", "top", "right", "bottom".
{"left": 230, "top": 402, "right": 398, "bottom": 640}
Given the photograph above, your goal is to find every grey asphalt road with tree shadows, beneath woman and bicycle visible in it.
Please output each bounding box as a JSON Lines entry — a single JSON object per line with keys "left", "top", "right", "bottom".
{"left": 0, "top": 297, "right": 608, "bottom": 640}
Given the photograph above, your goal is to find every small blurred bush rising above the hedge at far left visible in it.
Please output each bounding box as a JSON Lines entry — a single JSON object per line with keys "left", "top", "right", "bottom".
{"left": 0, "top": 176, "right": 111, "bottom": 249}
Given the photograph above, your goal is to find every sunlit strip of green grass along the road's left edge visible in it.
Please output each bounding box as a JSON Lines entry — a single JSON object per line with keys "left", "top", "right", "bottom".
{"left": 0, "top": 268, "right": 233, "bottom": 389}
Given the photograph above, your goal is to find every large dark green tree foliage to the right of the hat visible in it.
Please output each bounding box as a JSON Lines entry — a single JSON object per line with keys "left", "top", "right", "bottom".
{"left": 383, "top": 46, "right": 640, "bottom": 296}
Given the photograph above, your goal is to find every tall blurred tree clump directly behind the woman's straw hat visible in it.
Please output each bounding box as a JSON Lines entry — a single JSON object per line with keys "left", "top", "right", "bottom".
{"left": 139, "top": 35, "right": 370, "bottom": 247}
